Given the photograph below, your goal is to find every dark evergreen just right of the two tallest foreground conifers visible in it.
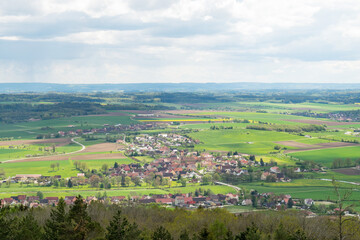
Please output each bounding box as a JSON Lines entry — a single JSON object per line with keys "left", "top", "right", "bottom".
{"left": 106, "top": 210, "right": 141, "bottom": 240}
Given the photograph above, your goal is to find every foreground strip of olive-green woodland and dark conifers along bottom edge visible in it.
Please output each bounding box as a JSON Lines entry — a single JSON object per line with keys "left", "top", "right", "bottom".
{"left": 0, "top": 196, "right": 360, "bottom": 240}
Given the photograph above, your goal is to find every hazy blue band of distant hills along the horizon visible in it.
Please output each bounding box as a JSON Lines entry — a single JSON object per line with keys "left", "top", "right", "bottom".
{"left": 0, "top": 82, "right": 360, "bottom": 93}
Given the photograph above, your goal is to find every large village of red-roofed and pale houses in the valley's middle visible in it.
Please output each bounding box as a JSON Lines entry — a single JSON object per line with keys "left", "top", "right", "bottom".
{"left": 1, "top": 133, "right": 338, "bottom": 216}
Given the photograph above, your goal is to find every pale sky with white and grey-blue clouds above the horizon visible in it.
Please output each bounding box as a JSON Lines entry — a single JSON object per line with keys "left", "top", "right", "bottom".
{"left": 0, "top": 0, "right": 360, "bottom": 84}
